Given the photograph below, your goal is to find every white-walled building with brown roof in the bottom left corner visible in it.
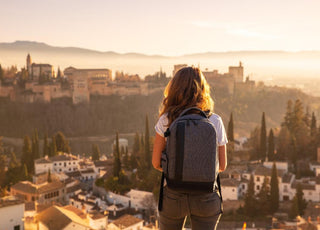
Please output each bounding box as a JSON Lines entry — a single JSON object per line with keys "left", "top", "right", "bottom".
{"left": 0, "top": 196, "right": 24, "bottom": 230}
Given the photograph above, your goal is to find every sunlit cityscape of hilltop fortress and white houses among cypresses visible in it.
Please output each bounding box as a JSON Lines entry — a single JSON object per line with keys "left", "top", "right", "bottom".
{"left": 0, "top": 54, "right": 320, "bottom": 230}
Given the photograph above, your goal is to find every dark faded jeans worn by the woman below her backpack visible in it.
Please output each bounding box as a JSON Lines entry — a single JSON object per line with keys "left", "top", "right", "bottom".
{"left": 160, "top": 186, "right": 222, "bottom": 230}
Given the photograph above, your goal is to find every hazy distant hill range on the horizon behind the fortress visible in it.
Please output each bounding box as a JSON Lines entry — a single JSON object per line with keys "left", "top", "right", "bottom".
{"left": 0, "top": 41, "right": 320, "bottom": 80}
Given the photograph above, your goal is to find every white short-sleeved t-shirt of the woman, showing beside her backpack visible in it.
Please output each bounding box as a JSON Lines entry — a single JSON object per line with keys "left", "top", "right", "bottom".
{"left": 154, "top": 113, "right": 228, "bottom": 146}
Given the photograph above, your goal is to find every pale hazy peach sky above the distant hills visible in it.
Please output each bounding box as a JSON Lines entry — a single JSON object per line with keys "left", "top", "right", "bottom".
{"left": 0, "top": 0, "right": 320, "bottom": 55}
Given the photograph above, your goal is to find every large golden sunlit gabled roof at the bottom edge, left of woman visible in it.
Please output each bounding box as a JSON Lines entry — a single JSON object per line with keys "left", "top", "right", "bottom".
{"left": 36, "top": 206, "right": 91, "bottom": 229}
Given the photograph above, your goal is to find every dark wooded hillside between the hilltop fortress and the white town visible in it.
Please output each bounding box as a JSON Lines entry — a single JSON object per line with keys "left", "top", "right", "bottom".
{"left": 0, "top": 83, "right": 320, "bottom": 138}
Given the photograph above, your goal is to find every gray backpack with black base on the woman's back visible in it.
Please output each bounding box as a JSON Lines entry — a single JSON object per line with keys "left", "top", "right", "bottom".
{"left": 161, "top": 107, "right": 219, "bottom": 192}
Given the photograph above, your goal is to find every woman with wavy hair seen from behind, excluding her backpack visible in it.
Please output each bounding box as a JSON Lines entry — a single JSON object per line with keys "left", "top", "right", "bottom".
{"left": 152, "top": 67, "right": 228, "bottom": 230}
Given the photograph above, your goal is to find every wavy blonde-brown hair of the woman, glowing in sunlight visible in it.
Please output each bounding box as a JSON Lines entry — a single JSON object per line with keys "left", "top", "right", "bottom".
{"left": 159, "top": 67, "right": 214, "bottom": 126}
